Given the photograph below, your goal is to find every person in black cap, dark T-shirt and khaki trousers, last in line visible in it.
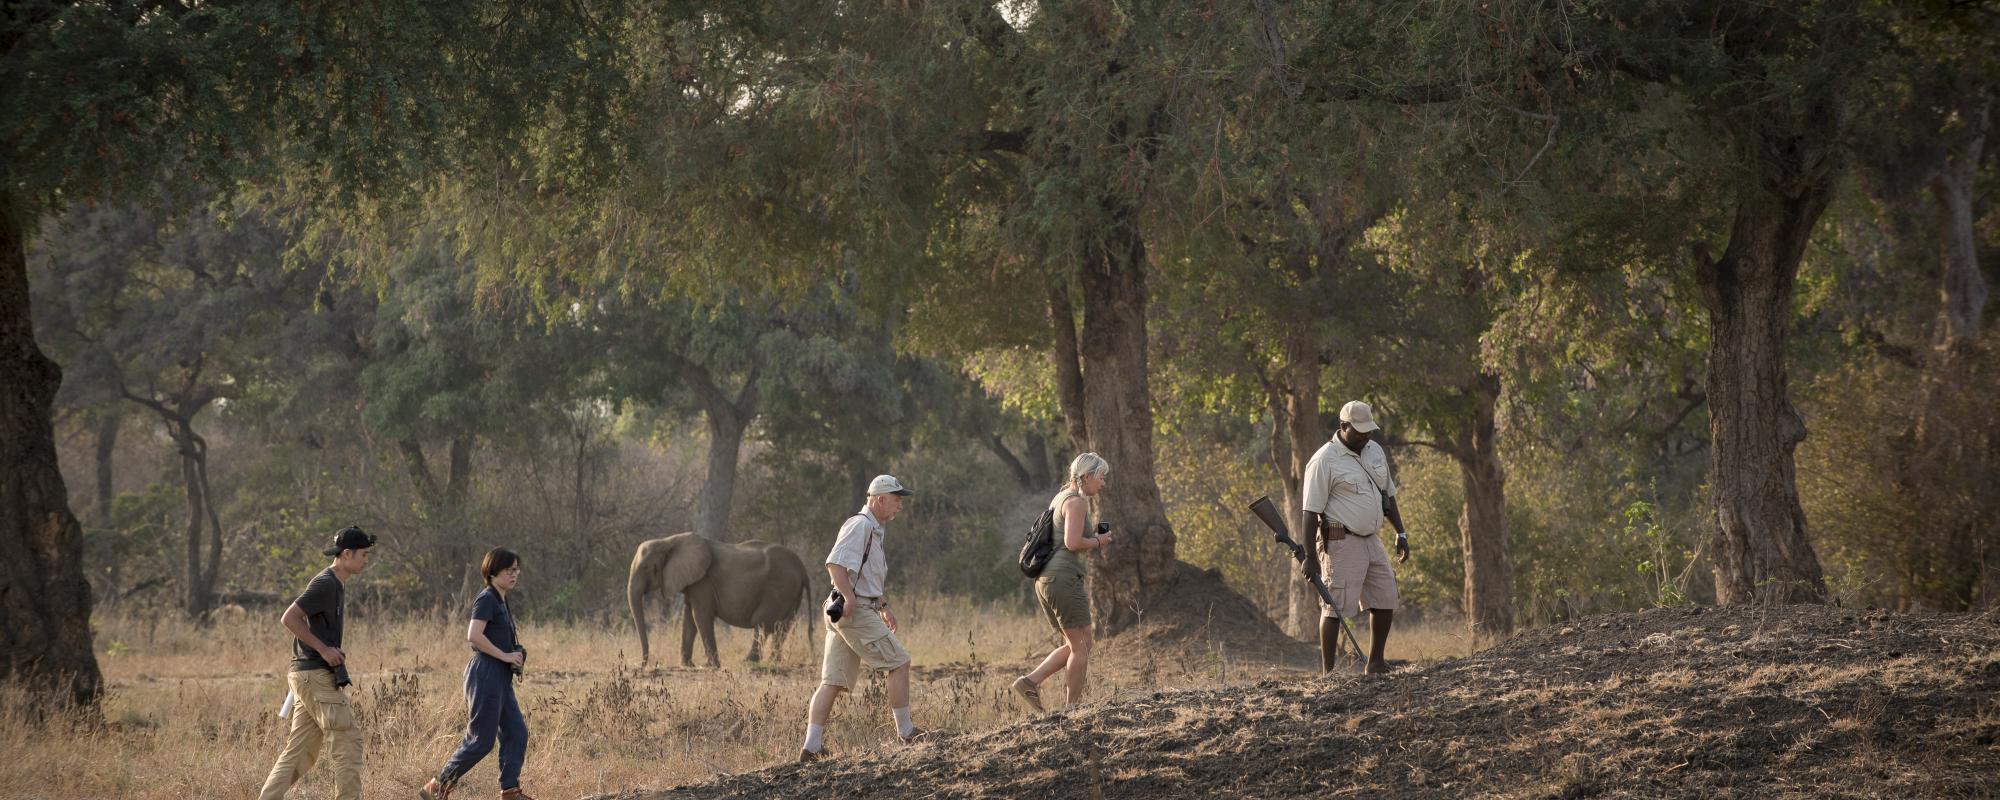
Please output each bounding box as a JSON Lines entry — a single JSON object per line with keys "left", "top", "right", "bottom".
{"left": 258, "top": 528, "right": 374, "bottom": 800}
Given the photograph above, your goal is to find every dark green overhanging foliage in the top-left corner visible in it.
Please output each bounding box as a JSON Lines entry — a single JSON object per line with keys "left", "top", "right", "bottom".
{"left": 0, "top": 0, "right": 622, "bottom": 224}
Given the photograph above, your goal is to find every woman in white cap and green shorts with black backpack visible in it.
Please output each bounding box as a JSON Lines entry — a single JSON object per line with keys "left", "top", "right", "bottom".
{"left": 1014, "top": 452, "right": 1112, "bottom": 710}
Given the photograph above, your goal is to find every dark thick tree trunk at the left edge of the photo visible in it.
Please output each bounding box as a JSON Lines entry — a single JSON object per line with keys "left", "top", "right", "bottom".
{"left": 0, "top": 203, "right": 104, "bottom": 708}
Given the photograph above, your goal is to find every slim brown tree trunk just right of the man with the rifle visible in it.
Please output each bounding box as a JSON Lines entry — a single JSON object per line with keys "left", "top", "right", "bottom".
{"left": 1452, "top": 372, "right": 1514, "bottom": 638}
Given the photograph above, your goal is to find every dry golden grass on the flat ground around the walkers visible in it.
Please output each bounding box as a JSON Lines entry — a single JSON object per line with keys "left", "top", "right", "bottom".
{"left": 0, "top": 596, "right": 1470, "bottom": 800}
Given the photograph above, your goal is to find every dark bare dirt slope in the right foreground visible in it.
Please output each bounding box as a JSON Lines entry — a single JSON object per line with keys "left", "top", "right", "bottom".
{"left": 602, "top": 606, "right": 2000, "bottom": 800}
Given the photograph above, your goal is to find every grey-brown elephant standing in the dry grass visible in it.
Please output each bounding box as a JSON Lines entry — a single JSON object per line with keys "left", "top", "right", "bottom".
{"left": 626, "top": 532, "right": 812, "bottom": 668}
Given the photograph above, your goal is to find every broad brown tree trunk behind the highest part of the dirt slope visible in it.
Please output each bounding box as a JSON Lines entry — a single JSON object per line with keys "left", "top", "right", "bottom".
{"left": 1696, "top": 177, "right": 1832, "bottom": 606}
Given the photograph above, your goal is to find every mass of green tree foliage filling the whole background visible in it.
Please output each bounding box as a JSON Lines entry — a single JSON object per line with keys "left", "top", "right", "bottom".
{"left": 23, "top": 0, "right": 2000, "bottom": 624}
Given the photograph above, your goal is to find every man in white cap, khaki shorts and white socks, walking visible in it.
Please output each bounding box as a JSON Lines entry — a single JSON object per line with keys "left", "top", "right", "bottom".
{"left": 798, "top": 474, "right": 924, "bottom": 764}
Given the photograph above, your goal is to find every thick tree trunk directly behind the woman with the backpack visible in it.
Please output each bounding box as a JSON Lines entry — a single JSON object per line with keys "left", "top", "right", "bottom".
{"left": 1088, "top": 208, "right": 1174, "bottom": 634}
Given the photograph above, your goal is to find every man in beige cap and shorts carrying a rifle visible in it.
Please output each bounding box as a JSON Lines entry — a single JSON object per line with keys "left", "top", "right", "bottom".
{"left": 1302, "top": 400, "right": 1410, "bottom": 672}
